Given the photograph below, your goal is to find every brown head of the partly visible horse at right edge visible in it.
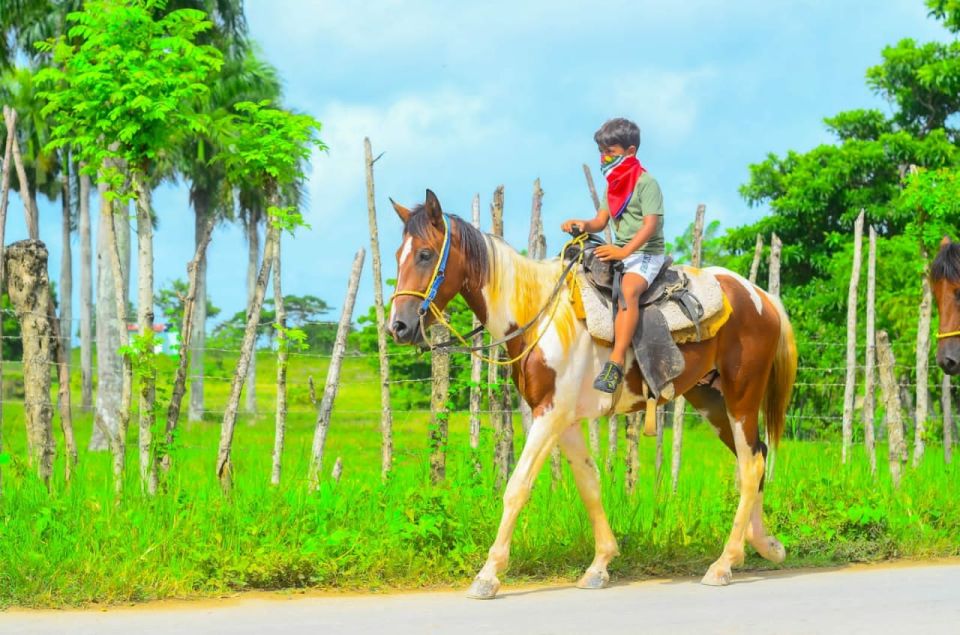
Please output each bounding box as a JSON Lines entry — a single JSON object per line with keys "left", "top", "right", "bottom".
{"left": 930, "top": 236, "right": 960, "bottom": 375}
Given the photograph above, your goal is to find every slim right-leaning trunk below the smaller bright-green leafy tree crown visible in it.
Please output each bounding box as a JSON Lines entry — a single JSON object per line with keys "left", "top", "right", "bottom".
{"left": 217, "top": 220, "right": 280, "bottom": 492}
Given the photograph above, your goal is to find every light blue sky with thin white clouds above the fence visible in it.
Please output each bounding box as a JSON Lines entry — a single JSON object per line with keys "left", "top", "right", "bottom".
{"left": 6, "top": 0, "right": 947, "bottom": 328}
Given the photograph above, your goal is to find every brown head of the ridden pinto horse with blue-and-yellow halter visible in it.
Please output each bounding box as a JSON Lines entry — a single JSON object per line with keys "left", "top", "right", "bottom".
{"left": 387, "top": 190, "right": 489, "bottom": 344}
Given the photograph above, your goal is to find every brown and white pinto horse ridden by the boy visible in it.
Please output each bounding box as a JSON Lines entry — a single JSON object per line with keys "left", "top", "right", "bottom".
{"left": 388, "top": 190, "right": 797, "bottom": 599}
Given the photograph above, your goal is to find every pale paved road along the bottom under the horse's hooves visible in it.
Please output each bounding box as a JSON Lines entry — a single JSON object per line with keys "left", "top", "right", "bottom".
{"left": 0, "top": 563, "right": 960, "bottom": 635}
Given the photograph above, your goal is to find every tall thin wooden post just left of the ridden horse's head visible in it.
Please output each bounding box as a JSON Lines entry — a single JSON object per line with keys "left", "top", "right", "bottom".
{"left": 363, "top": 137, "right": 393, "bottom": 480}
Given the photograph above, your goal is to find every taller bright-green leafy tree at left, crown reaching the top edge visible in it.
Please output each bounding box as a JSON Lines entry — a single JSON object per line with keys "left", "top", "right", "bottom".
{"left": 37, "top": 0, "right": 222, "bottom": 492}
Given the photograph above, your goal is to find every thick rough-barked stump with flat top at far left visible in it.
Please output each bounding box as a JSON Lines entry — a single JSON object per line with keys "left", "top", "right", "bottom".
{"left": 4, "top": 240, "right": 55, "bottom": 488}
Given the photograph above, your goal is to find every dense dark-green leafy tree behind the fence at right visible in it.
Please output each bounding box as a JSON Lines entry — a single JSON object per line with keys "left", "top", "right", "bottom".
{"left": 724, "top": 0, "right": 960, "bottom": 429}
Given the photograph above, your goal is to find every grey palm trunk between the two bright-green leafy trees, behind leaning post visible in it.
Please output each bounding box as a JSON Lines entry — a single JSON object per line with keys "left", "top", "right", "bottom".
{"left": 187, "top": 190, "right": 213, "bottom": 421}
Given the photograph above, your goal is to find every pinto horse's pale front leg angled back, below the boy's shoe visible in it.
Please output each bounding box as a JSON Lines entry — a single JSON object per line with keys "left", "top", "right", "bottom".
{"left": 560, "top": 424, "right": 620, "bottom": 589}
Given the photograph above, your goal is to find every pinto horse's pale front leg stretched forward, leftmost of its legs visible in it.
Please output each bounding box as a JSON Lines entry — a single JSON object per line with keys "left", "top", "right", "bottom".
{"left": 467, "top": 410, "right": 569, "bottom": 600}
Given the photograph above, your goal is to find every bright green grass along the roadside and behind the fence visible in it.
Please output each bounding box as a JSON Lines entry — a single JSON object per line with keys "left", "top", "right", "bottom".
{"left": 0, "top": 354, "right": 960, "bottom": 606}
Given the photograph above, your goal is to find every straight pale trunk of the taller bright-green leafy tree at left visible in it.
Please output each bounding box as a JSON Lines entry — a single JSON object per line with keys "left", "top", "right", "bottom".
{"left": 133, "top": 171, "right": 157, "bottom": 496}
